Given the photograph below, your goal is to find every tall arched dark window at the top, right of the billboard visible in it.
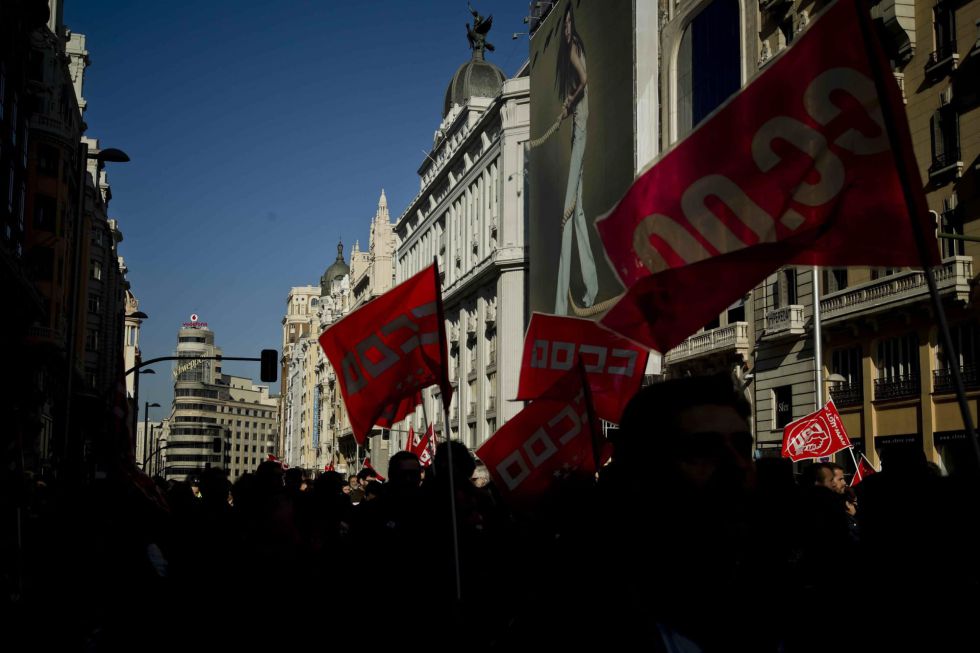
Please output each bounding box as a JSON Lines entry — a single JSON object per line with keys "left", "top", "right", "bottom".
{"left": 677, "top": 0, "right": 742, "bottom": 138}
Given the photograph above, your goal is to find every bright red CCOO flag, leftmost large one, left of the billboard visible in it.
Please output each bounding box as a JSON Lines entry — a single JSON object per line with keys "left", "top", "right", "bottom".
{"left": 320, "top": 265, "right": 452, "bottom": 444}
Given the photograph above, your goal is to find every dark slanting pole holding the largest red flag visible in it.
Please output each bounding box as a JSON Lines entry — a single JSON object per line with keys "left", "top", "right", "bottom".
{"left": 854, "top": 2, "right": 980, "bottom": 465}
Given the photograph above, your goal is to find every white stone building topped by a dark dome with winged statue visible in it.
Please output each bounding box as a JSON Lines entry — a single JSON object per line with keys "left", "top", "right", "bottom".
{"left": 391, "top": 42, "right": 530, "bottom": 449}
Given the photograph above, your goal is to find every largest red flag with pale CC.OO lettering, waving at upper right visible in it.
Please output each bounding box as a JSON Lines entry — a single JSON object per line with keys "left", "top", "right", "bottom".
{"left": 596, "top": 0, "right": 939, "bottom": 351}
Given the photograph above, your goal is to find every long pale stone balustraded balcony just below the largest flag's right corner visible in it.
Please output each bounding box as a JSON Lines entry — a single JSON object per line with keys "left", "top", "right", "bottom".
{"left": 820, "top": 256, "right": 973, "bottom": 325}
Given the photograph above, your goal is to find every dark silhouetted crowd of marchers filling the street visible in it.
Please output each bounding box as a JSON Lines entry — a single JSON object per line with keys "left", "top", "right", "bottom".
{"left": 5, "top": 377, "right": 980, "bottom": 653}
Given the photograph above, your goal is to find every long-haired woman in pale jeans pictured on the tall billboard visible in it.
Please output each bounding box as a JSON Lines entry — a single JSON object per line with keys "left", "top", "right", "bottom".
{"left": 555, "top": 3, "right": 599, "bottom": 315}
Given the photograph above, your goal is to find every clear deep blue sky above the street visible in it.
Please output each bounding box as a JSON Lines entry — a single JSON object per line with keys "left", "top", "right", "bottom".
{"left": 65, "top": 0, "right": 528, "bottom": 412}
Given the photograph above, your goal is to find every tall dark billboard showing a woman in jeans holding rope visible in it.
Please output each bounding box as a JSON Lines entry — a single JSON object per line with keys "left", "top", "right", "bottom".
{"left": 528, "top": 0, "right": 634, "bottom": 319}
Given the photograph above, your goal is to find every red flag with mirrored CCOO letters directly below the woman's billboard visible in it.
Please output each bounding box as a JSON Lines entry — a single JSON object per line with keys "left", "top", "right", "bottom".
{"left": 517, "top": 313, "right": 649, "bottom": 423}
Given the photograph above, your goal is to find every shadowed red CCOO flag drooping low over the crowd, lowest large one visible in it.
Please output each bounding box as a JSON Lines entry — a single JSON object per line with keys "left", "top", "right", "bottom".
{"left": 476, "top": 370, "right": 596, "bottom": 502}
